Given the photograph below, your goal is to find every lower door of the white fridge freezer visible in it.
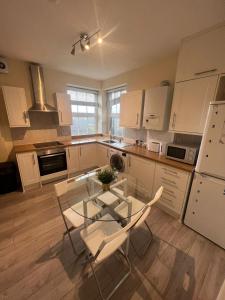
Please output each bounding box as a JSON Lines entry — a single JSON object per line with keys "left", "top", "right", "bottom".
{"left": 184, "top": 173, "right": 225, "bottom": 248}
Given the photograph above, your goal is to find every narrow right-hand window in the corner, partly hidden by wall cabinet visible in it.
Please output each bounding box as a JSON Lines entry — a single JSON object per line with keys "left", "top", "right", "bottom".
{"left": 107, "top": 87, "right": 126, "bottom": 136}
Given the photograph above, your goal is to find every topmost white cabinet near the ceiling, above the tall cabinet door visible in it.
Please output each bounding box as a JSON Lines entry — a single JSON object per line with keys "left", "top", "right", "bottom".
{"left": 176, "top": 25, "right": 225, "bottom": 82}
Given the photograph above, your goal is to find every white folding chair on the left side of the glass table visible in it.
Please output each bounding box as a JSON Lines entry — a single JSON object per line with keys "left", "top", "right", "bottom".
{"left": 54, "top": 174, "right": 102, "bottom": 255}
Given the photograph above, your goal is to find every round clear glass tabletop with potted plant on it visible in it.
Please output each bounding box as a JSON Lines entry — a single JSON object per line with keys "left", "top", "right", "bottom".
{"left": 60, "top": 170, "right": 151, "bottom": 222}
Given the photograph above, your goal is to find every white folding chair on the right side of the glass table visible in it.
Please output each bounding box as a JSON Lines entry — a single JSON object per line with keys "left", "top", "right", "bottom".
{"left": 115, "top": 186, "right": 163, "bottom": 256}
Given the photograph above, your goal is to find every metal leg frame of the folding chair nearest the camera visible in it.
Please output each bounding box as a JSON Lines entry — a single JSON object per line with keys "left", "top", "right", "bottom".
{"left": 88, "top": 250, "right": 131, "bottom": 300}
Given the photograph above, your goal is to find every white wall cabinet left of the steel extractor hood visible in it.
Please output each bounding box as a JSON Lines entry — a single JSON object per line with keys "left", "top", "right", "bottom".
{"left": 2, "top": 86, "right": 30, "bottom": 127}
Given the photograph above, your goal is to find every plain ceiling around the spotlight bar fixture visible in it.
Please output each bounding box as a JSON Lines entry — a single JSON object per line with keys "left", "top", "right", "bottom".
{"left": 0, "top": 0, "right": 225, "bottom": 80}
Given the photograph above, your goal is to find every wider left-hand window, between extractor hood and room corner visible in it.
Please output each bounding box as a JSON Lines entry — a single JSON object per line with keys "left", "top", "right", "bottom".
{"left": 67, "top": 86, "right": 98, "bottom": 135}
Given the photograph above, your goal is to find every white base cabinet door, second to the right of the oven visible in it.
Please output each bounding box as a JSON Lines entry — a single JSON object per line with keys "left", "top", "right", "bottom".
{"left": 79, "top": 143, "right": 97, "bottom": 170}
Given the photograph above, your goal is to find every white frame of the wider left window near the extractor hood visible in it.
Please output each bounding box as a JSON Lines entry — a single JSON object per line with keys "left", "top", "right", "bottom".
{"left": 66, "top": 85, "right": 100, "bottom": 137}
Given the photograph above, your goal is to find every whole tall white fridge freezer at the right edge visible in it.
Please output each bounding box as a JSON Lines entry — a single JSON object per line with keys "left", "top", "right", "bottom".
{"left": 184, "top": 101, "right": 225, "bottom": 248}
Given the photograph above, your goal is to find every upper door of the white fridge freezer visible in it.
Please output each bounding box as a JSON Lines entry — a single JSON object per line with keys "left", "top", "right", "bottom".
{"left": 196, "top": 101, "right": 225, "bottom": 179}
